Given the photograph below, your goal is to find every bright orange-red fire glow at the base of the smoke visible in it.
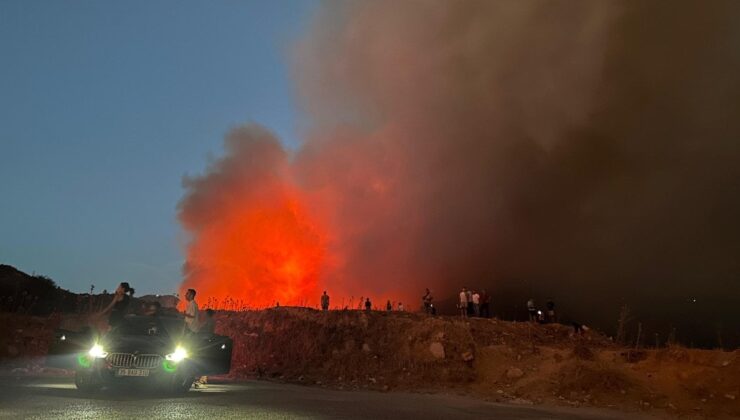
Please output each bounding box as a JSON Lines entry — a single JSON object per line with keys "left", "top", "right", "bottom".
{"left": 181, "top": 182, "right": 325, "bottom": 309}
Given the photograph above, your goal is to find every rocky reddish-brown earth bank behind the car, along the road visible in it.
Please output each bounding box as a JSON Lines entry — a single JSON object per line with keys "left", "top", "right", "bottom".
{"left": 0, "top": 308, "right": 740, "bottom": 418}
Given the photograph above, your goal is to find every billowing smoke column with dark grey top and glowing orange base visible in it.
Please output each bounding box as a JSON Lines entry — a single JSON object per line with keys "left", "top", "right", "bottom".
{"left": 180, "top": 127, "right": 325, "bottom": 308}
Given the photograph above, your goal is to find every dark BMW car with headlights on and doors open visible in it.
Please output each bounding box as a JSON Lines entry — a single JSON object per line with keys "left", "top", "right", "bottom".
{"left": 46, "top": 315, "right": 233, "bottom": 393}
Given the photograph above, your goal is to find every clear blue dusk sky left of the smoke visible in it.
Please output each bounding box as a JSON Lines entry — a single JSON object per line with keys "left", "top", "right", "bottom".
{"left": 0, "top": 0, "right": 316, "bottom": 295}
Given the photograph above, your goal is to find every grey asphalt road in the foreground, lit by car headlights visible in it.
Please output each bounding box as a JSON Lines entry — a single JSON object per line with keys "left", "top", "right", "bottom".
{"left": 0, "top": 378, "right": 635, "bottom": 420}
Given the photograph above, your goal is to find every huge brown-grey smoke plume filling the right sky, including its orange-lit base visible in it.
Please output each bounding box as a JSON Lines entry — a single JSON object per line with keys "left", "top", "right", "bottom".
{"left": 180, "top": 0, "right": 740, "bottom": 334}
